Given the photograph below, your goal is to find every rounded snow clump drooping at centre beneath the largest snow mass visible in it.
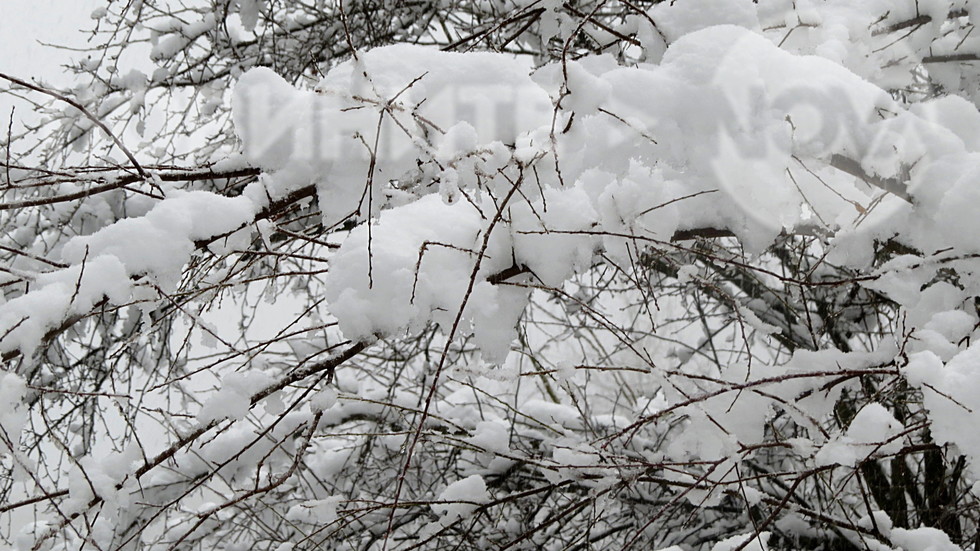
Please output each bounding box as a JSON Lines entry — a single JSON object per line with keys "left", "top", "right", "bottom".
{"left": 326, "top": 195, "right": 527, "bottom": 361}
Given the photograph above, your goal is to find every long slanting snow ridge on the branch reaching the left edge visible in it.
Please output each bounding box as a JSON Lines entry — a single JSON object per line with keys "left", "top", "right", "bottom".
{"left": 0, "top": 191, "right": 257, "bottom": 355}
